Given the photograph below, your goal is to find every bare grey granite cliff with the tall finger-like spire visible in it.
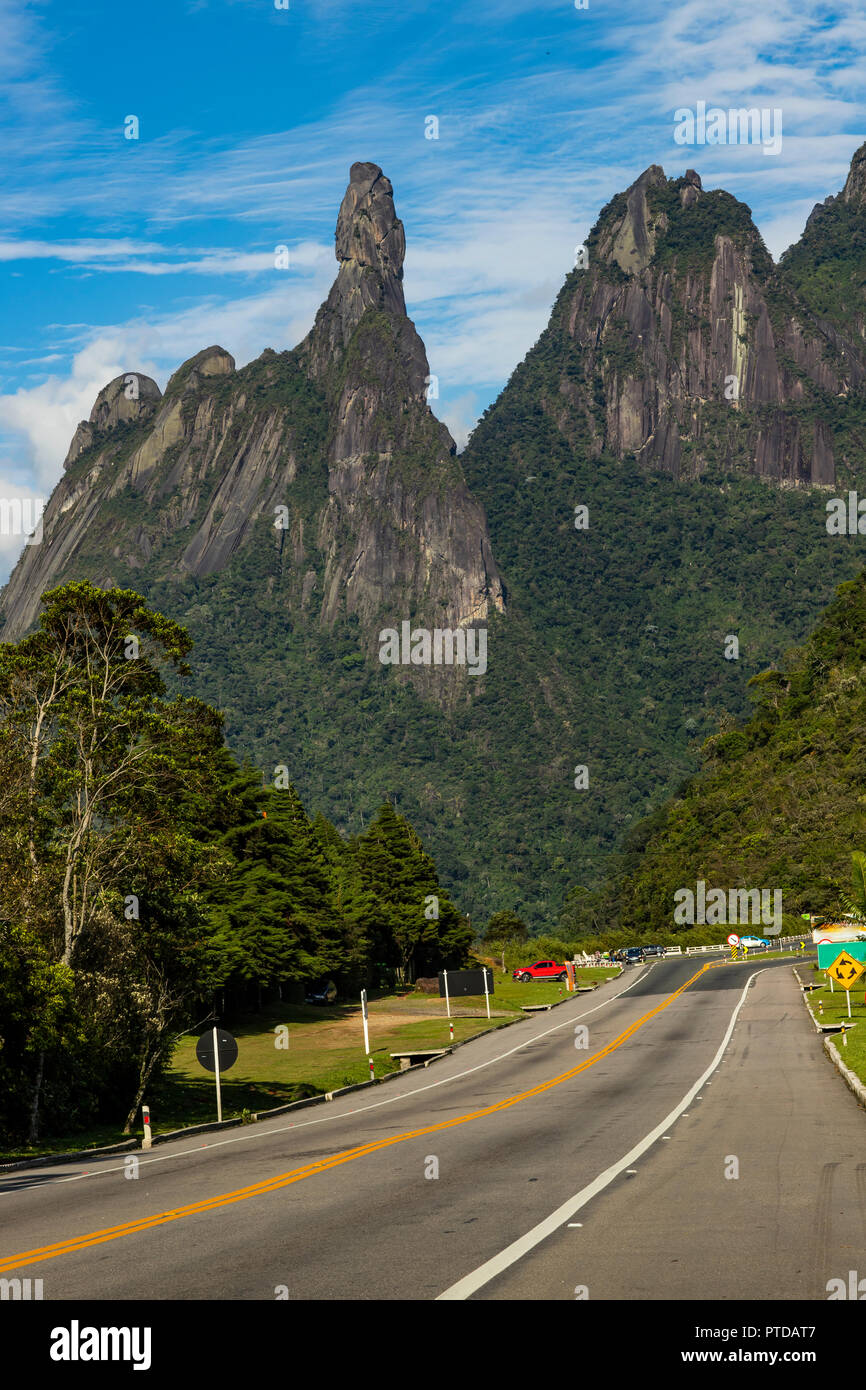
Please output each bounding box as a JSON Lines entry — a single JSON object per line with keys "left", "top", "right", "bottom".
{"left": 1, "top": 164, "right": 505, "bottom": 658}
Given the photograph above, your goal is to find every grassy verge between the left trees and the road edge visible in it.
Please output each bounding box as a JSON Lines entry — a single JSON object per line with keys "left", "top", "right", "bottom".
{"left": 0, "top": 967, "right": 614, "bottom": 1162}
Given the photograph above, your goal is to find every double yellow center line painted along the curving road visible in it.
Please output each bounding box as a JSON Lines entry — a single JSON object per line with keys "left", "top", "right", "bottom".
{"left": 0, "top": 960, "right": 727, "bottom": 1275}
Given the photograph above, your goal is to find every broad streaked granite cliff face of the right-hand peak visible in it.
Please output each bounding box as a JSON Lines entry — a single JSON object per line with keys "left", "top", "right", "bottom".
{"left": 536, "top": 152, "right": 866, "bottom": 487}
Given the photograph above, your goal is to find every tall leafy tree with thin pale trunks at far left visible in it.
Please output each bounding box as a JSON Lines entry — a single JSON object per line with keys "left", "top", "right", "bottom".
{"left": 0, "top": 582, "right": 222, "bottom": 1141}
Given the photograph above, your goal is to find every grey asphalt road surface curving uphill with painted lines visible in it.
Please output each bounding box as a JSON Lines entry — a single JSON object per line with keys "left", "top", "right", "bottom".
{"left": 0, "top": 958, "right": 866, "bottom": 1301}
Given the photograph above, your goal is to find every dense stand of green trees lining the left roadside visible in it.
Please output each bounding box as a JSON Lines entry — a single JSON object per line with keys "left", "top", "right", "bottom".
{"left": 0, "top": 582, "right": 471, "bottom": 1144}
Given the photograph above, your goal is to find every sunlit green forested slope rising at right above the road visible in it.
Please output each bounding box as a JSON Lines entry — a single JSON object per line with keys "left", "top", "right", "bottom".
{"left": 562, "top": 573, "right": 866, "bottom": 940}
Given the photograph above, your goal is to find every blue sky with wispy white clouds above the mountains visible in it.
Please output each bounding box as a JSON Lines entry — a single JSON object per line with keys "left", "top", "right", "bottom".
{"left": 0, "top": 0, "right": 866, "bottom": 580}
